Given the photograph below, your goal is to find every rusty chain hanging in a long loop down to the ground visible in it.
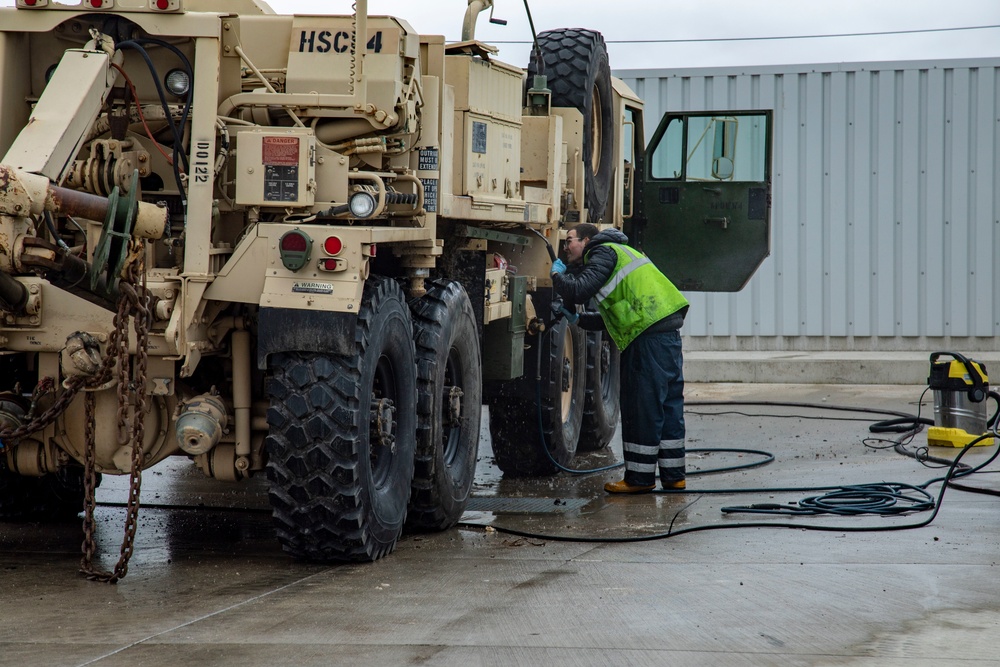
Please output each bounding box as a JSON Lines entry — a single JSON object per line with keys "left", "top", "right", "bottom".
{"left": 80, "top": 248, "right": 151, "bottom": 584}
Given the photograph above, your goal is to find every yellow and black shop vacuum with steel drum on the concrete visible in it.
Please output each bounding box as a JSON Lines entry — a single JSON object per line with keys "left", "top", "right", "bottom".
{"left": 927, "top": 352, "right": 996, "bottom": 447}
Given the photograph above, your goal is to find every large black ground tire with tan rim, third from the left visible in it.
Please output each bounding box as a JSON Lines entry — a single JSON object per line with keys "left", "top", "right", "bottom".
{"left": 489, "top": 319, "right": 586, "bottom": 477}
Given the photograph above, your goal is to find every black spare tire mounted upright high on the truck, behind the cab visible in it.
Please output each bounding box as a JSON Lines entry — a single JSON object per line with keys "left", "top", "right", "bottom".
{"left": 528, "top": 28, "right": 615, "bottom": 223}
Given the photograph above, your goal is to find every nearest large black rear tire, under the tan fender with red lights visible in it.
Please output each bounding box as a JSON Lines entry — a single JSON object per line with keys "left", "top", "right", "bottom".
{"left": 267, "top": 278, "right": 417, "bottom": 561}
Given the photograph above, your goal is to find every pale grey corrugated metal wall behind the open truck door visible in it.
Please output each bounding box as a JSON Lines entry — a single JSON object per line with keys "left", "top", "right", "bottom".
{"left": 615, "top": 59, "right": 1000, "bottom": 351}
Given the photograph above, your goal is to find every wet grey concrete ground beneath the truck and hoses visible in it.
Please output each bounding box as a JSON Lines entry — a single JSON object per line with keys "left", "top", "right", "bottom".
{"left": 0, "top": 384, "right": 1000, "bottom": 667}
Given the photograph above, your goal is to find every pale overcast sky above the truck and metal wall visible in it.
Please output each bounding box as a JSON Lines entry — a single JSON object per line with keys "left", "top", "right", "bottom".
{"left": 0, "top": 0, "right": 1000, "bottom": 69}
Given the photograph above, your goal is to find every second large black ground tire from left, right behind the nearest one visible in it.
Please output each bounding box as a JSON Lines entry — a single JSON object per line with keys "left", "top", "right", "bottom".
{"left": 407, "top": 280, "right": 483, "bottom": 530}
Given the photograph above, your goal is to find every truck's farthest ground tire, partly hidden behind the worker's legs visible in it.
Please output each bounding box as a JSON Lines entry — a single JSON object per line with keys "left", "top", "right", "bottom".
{"left": 576, "top": 331, "right": 621, "bottom": 452}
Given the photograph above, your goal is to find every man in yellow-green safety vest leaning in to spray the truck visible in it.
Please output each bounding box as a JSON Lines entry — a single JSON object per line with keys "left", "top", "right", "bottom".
{"left": 552, "top": 223, "right": 688, "bottom": 493}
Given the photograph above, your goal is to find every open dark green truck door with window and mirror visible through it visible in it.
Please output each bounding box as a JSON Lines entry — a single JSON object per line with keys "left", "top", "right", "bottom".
{"left": 625, "top": 110, "right": 772, "bottom": 292}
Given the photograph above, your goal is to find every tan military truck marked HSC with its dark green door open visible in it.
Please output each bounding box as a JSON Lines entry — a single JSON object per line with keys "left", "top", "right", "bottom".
{"left": 0, "top": 0, "right": 770, "bottom": 580}
